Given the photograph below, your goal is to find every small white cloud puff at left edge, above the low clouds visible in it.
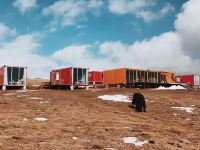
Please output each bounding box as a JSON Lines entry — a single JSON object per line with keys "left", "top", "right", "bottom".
{"left": 0, "top": 23, "right": 16, "bottom": 41}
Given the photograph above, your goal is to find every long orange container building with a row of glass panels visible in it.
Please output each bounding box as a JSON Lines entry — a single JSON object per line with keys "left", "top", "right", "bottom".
{"left": 103, "top": 68, "right": 175, "bottom": 87}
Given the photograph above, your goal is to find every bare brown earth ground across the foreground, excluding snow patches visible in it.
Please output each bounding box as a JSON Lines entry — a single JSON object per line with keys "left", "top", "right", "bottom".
{"left": 0, "top": 88, "right": 200, "bottom": 150}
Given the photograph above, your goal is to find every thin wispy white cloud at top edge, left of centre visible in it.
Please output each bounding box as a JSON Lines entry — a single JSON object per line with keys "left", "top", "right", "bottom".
{"left": 42, "top": 0, "right": 103, "bottom": 26}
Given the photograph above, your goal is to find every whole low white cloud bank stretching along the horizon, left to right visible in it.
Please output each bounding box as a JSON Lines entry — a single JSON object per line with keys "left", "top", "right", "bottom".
{"left": 0, "top": 0, "right": 200, "bottom": 77}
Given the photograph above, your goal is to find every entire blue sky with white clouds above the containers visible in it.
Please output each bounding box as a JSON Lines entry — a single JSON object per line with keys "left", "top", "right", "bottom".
{"left": 0, "top": 0, "right": 200, "bottom": 77}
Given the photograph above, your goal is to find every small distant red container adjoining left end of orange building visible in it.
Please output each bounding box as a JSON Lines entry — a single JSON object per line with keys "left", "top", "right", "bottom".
{"left": 89, "top": 71, "right": 103, "bottom": 84}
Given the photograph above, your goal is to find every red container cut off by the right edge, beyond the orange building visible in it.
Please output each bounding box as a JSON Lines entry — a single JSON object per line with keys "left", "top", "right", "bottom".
{"left": 175, "top": 75, "right": 200, "bottom": 86}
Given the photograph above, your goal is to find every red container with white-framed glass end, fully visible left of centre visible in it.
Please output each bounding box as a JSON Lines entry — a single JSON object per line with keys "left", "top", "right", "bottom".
{"left": 50, "top": 67, "right": 88, "bottom": 87}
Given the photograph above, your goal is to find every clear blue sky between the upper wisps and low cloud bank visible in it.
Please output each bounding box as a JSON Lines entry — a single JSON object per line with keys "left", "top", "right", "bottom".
{"left": 0, "top": 0, "right": 184, "bottom": 55}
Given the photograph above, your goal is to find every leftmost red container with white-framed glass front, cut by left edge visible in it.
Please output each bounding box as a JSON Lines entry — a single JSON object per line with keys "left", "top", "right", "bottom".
{"left": 0, "top": 65, "right": 27, "bottom": 90}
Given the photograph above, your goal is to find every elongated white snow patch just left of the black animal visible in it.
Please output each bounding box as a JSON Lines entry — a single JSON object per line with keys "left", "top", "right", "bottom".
{"left": 98, "top": 94, "right": 131, "bottom": 103}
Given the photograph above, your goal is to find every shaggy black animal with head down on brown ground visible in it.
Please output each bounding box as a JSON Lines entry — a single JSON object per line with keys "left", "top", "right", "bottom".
{"left": 132, "top": 93, "right": 146, "bottom": 112}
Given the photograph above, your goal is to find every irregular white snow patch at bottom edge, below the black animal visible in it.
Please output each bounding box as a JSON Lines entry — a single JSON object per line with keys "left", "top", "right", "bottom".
{"left": 122, "top": 137, "right": 148, "bottom": 147}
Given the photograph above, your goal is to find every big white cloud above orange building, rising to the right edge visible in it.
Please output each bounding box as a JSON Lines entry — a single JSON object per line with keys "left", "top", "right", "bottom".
{"left": 53, "top": 0, "right": 200, "bottom": 74}
